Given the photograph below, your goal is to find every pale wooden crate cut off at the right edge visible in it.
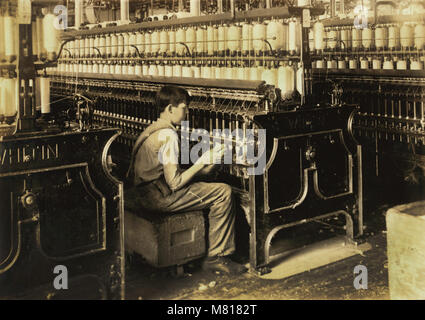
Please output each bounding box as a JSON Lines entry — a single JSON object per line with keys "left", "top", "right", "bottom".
{"left": 386, "top": 201, "right": 425, "bottom": 300}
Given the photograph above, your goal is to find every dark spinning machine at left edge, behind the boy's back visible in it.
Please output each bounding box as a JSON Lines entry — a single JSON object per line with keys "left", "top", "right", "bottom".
{"left": 0, "top": 1, "right": 124, "bottom": 299}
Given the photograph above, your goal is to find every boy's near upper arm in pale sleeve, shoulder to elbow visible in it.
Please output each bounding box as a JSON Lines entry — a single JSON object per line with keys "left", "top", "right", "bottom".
{"left": 158, "top": 130, "right": 182, "bottom": 191}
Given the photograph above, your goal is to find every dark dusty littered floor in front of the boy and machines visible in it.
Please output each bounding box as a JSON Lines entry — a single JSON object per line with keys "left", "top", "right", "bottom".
{"left": 126, "top": 208, "right": 389, "bottom": 300}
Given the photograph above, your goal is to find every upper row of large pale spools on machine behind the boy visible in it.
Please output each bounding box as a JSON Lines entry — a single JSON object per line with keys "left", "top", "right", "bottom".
{"left": 64, "top": 18, "right": 301, "bottom": 58}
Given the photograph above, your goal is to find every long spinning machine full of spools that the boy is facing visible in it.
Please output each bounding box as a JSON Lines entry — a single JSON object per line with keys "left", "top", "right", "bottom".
{"left": 48, "top": 1, "right": 363, "bottom": 273}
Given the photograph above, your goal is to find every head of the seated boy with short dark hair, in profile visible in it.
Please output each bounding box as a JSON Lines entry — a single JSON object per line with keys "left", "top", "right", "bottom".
{"left": 155, "top": 86, "right": 190, "bottom": 125}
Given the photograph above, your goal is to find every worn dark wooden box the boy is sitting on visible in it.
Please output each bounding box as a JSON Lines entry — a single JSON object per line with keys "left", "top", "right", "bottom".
{"left": 124, "top": 210, "right": 206, "bottom": 267}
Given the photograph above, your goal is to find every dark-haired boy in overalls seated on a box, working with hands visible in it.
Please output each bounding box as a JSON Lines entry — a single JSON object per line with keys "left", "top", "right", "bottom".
{"left": 128, "top": 86, "right": 245, "bottom": 273}
